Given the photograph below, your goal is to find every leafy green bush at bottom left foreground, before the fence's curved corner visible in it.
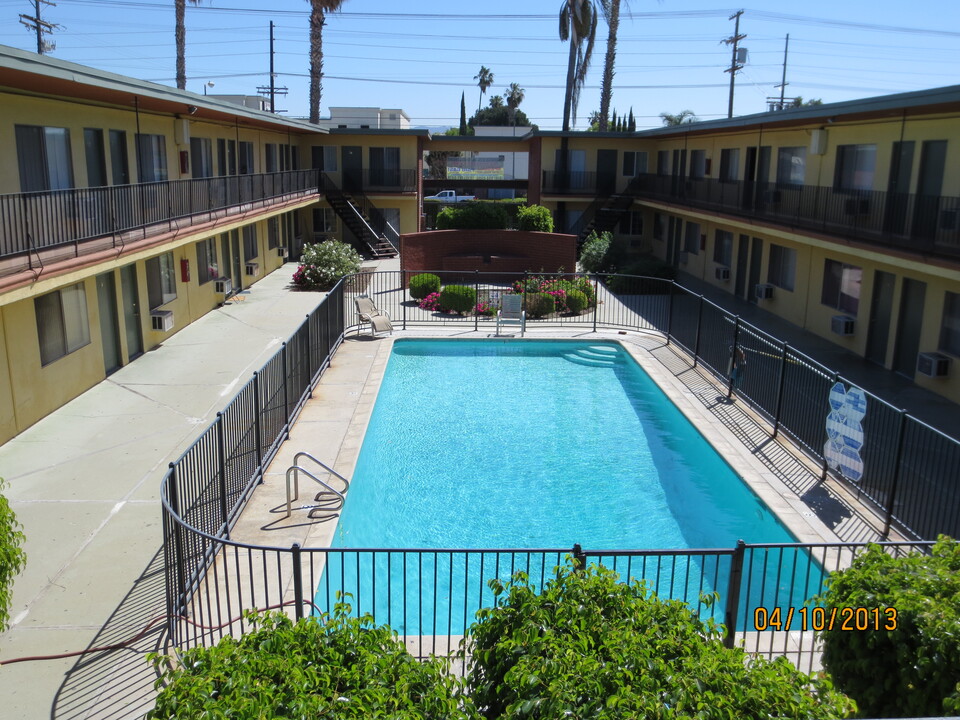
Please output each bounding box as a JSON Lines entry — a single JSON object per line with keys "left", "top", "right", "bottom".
{"left": 147, "top": 606, "right": 479, "bottom": 720}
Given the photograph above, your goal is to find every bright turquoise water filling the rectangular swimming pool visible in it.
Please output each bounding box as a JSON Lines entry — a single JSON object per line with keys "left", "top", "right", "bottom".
{"left": 316, "top": 340, "right": 824, "bottom": 634}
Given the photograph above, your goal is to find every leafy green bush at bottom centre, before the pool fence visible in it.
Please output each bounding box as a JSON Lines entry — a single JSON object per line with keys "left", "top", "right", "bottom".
{"left": 470, "top": 566, "right": 852, "bottom": 720}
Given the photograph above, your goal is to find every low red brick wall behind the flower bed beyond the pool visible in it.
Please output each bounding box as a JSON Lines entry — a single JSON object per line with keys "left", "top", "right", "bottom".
{"left": 400, "top": 230, "right": 577, "bottom": 279}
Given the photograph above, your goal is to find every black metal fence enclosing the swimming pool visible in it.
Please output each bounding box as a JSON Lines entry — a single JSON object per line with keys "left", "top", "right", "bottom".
{"left": 161, "top": 272, "right": 960, "bottom": 669}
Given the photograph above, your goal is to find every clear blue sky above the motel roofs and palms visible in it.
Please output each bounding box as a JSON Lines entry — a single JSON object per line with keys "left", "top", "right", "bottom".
{"left": 0, "top": 0, "right": 960, "bottom": 129}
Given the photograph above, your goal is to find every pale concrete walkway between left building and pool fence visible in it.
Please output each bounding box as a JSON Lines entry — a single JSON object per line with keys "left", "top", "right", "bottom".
{"left": 0, "top": 263, "right": 384, "bottom": 720}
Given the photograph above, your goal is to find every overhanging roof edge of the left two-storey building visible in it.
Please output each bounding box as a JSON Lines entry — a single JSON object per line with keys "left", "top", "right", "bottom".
{"left": 0, "top": 45, "right": 325, "bottom": 133}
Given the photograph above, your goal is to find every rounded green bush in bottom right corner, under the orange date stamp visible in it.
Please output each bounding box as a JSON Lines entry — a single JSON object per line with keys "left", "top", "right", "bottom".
{"left": 821, "top": 537, "right": 960, "bottom": 717}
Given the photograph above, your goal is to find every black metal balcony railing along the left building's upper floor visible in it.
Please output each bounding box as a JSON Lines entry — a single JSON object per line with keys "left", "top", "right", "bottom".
{"left": 0, "top": 170, "right": 318, "bottom": 266}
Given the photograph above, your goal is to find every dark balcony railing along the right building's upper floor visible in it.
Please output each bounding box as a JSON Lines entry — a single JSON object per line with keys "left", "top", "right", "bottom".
{"left": 637, "top": 174, "right": 960, "bottom": 258}
